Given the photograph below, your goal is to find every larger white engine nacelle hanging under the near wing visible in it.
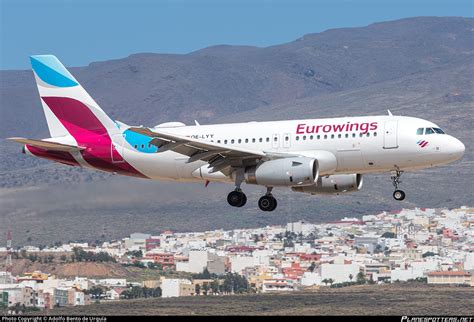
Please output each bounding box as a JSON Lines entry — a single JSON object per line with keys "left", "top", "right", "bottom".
{"left": 244, "top": 157, "right": 319, "bottom": 187}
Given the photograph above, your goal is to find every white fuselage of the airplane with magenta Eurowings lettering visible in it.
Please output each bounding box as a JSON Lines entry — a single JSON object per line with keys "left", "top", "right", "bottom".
{"left": 113, "top": 115, "right": 464, "bottom": 181}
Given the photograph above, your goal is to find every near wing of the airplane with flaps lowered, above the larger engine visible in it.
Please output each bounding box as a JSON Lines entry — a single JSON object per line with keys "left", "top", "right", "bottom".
{"left": 128, "top": 127, "right": 270, "bottom": 175}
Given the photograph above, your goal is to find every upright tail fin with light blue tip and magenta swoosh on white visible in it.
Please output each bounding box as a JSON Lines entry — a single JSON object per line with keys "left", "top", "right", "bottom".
{"left": 30, "top": 55, "right": 119, "bottom": 138}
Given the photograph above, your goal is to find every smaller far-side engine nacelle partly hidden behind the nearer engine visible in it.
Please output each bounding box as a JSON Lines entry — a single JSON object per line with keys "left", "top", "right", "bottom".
{"left": 291, "top": 174, "right": 363, "bottom": 194}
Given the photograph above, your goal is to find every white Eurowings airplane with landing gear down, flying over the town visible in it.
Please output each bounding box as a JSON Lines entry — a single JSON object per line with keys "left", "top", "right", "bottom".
{"left": 9, "top": 55, "right": 465, "bottom": 211}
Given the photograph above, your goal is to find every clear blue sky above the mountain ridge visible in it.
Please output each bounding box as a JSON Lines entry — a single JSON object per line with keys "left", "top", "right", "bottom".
{"left": 0, "top": 0, "right": 474, "bottom": 70}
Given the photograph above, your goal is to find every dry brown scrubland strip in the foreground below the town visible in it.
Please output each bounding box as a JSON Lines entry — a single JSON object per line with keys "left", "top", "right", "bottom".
{"left": 46, "top": 284, "right": 474, "bottom": 315}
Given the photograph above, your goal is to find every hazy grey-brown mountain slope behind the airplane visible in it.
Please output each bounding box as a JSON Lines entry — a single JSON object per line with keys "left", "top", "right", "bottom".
{"left": 0, "top": 17, "right": 474, "bottom": 242}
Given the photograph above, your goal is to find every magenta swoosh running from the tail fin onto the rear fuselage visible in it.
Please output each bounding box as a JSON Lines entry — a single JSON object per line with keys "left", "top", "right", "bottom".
{"left": 41, "top": 97, "right": 146, "bottom": 178}
